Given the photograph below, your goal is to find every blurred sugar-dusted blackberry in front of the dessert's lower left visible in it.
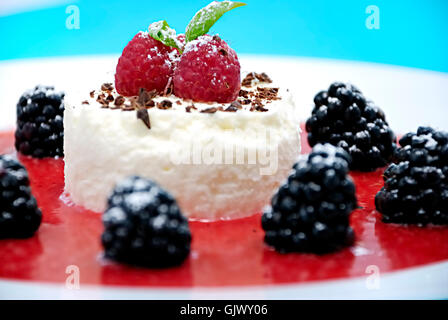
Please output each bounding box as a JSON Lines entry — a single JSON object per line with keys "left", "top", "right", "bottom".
{"left": 102, "top": 176, "right": 191, "bottom": 268}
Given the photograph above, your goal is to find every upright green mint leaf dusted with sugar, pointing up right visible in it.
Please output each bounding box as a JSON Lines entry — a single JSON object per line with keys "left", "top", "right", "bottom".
{"left": 185, "top": 1, "right": 246, "bottom": 43}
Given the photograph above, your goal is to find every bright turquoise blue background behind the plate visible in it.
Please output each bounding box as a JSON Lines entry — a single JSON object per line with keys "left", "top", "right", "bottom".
{"left": 0, "top": 0, "right": 448, "bottom": 72}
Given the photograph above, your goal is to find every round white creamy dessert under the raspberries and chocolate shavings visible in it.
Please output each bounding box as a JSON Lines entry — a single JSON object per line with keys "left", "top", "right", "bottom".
{"left": 64, "top": 79, "right": 300, "bottom": 220}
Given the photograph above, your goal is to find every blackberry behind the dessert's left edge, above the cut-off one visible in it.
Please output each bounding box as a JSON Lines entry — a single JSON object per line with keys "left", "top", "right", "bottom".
{"left": 15, "top": 85, "right": 64, "bottom": 158}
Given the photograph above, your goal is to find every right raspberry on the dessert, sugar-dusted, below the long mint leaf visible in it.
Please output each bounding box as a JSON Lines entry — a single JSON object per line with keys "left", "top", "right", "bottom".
{"left": 173, "top": 35, "right": 241, "bottom": 103}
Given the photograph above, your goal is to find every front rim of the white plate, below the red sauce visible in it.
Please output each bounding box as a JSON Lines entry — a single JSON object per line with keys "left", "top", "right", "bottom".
{"left": 0, "top": 262, "right": 448, "bottom": 300}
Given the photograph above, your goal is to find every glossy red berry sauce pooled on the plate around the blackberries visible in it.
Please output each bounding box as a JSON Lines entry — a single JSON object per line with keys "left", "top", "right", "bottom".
{"left": 0, "top": 132, "right": 448, "bottom": 287}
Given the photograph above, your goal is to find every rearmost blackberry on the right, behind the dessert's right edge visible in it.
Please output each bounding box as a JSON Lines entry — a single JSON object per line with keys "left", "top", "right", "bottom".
{"left": 306, "top": 82, "right": 396, "bottom": 171}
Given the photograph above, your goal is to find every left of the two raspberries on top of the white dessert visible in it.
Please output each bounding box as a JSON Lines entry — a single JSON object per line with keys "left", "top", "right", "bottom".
{"left": 115, "top": 32, "right": 179, "bottom": 96}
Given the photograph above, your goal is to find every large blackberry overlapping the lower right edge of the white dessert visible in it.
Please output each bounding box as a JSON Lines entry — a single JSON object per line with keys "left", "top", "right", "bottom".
{"left": 262, "top": 144, "right": 357, "bottom": 253}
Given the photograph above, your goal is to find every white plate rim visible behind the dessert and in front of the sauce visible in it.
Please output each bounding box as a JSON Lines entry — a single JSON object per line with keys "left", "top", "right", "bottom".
{"left": 0, "top": 56, "right": 448, "bottom": 299}
